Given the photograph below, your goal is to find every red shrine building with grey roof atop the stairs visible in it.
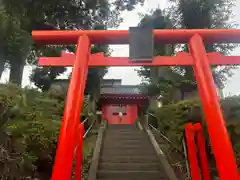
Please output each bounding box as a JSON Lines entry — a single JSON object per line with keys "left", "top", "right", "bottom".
{"left": 100, "top": 79, "right": 148, "bottom": 124}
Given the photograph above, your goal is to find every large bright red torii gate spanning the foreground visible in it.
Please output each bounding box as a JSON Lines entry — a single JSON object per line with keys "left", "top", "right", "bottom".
{"left": 32, "top": 29, "right": 240, "bottom": 180}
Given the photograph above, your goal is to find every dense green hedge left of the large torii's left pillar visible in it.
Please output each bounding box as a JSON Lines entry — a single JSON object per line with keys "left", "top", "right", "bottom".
{"left": 0, "top": 84, "right": 92, "bottom": 180}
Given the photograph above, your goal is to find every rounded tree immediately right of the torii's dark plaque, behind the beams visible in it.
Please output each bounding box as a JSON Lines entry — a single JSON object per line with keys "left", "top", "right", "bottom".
{"left": 138, "top": 9, "right": 178, "bottom": 104}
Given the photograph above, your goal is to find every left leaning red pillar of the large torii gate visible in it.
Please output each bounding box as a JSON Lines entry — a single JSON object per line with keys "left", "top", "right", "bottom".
{"left": 52, "top": 36, "right": 90, "bottom": 180}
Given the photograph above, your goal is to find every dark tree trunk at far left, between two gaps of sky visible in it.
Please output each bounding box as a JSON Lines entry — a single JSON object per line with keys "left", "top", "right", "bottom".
{"left": 9, "top": 61, "right": 25, "bottom": 86}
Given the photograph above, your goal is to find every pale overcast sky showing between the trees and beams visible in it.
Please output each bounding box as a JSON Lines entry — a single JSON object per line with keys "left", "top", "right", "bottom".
{"left": 1, "top": 0, "right": 240, "bottom": 95}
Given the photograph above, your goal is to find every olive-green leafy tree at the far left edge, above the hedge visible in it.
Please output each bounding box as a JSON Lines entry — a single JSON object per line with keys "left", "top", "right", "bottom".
{"left": 0, "top": 6, "right": 31, "bottom": 83}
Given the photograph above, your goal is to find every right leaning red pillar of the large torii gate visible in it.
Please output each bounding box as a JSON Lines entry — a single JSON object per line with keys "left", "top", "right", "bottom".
{"left": 189, "top": 35, "right": 239, "bottom": 180}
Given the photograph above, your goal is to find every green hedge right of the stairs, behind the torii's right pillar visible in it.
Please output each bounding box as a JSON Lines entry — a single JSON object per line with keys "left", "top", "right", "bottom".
{"left": 155, "top": 96, "right": 240, "bottom": 169}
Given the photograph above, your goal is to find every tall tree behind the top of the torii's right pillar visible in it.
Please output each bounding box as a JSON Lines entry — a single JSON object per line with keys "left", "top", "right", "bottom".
{"left": 170, "top": 0, "right": 236, "bottom": 88}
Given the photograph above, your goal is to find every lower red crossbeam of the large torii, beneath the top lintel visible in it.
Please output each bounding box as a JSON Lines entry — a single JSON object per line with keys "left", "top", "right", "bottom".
{"left": 38, "top": 53, "right": 240, "bottom": 67}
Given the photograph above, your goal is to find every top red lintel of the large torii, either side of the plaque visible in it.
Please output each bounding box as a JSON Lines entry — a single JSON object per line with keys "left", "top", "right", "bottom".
{"left": 32, "top": 29, "right": 240, "bottom": 45}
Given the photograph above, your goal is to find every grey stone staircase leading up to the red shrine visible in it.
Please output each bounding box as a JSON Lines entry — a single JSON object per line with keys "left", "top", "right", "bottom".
{"left": 93, "top": 125, "right": 169, "bottom": 180}
